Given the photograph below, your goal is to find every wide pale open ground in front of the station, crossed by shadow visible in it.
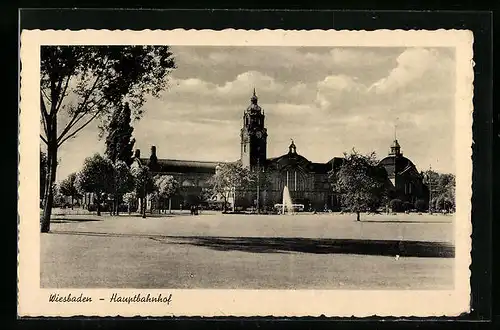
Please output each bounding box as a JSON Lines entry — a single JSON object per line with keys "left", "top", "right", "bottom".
{"left": 40, "top": 211, "right": 454, "bottom": 290}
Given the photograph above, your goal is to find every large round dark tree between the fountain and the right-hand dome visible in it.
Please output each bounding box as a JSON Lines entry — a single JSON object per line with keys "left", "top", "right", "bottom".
{"left": 334, "top": 149, "right": 387, "bottom": 221}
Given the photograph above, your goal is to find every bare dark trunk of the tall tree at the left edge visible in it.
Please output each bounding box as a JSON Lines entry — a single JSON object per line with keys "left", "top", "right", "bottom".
{"left": 40, "top": 125, "right": 57, "bottom": 233}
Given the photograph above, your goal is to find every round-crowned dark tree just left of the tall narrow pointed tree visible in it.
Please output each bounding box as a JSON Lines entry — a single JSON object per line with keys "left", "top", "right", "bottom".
{"left": 75, "top": 154, "right": 114, "bottom": 216}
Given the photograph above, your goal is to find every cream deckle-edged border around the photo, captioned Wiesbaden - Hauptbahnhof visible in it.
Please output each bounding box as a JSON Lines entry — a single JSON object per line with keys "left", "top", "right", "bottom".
{"left": 18, "top": 29, "right": 473, "bottom": 317}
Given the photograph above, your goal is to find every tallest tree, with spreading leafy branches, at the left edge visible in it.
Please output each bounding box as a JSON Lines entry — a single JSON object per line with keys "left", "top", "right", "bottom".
{"left": 40, "top": 46, "right": 175, "bottom": 232}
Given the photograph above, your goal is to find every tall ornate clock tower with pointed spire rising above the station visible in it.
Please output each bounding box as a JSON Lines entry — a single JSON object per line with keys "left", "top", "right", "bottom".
{"left": 240, "top": 88, "right": 267, "bottom": 169}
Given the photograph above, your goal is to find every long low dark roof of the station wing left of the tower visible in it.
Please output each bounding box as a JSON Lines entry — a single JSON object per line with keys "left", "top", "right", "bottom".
{"left": 140, "top": 158, "right": 225, "bottom": 173}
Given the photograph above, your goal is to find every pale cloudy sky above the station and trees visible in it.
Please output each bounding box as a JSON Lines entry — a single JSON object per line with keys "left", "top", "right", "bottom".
{"left": 52, "top": 46, "right": 455, "bottom": 180}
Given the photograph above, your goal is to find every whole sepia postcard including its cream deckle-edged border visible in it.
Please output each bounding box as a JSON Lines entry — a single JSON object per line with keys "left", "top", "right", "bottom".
{"left": 19, "top": 30, "right": 472, "bottom": 316}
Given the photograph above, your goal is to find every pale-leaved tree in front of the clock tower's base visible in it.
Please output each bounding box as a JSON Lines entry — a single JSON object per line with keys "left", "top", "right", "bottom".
{"left": 208, "top": 161, "right": 252, "bottom": 211}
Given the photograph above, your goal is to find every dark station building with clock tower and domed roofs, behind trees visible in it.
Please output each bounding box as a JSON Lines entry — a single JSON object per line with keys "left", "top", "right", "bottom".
{"left": 133, "top": 90, "right": 425, "bottom": 210}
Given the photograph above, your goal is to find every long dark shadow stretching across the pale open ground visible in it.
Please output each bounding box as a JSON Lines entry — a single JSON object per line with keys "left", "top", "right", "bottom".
{"left": 48, "top": 231, "right": 455, "bottom": 258}
